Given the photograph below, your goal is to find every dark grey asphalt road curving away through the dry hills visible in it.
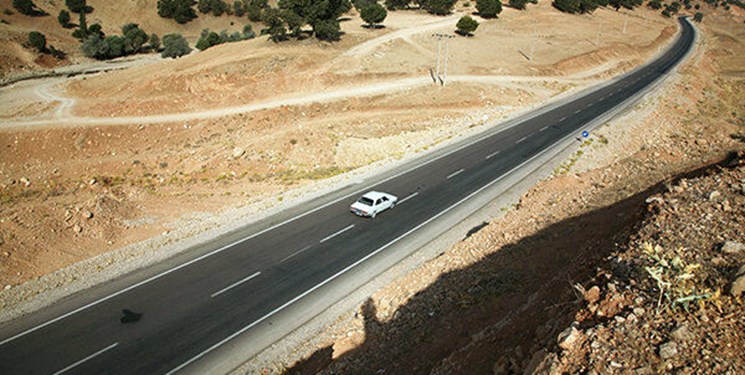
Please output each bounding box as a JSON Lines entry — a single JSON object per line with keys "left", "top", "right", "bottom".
{"left": 0, "top": 16, "right": 694, "bottom": 374}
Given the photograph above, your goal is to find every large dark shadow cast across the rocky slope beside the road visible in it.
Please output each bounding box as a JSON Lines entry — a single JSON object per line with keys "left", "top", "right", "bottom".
{"left": 287, "top": 157, "right": 732, "bottom": 374}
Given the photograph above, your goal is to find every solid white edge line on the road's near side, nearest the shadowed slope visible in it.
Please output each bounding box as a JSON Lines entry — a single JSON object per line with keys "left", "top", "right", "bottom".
{"left": 166, "top": 133, "right": 566, "bottom": 375}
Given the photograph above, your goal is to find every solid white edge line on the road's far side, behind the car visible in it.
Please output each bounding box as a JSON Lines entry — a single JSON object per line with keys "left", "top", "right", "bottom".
{"left": 0, "top": 118, "right": 508, "bottom": 346}
